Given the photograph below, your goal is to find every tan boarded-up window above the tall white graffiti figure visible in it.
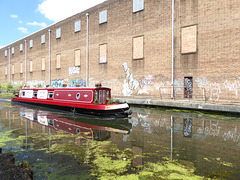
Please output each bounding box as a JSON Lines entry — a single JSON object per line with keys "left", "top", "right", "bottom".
{"left": 133, "top": 36, "right": 143, "bottom": 59}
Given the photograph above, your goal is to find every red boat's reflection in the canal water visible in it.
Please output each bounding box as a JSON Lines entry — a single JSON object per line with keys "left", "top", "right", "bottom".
{"left": 16, "top": 106, "right": 132, "bottom": 141}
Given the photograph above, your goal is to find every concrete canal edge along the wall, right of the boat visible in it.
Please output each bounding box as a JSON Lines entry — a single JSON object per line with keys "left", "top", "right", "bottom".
{"left": 113, "top": 97, "right": 240, "bottom": 113}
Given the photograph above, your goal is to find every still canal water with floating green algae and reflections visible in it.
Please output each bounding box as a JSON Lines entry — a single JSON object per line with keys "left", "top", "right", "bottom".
{"left": 0, "top": 100, "right": 240, "bottom": 179}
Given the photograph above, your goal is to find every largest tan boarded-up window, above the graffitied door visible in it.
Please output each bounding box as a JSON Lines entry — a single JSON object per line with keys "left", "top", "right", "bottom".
{"left": 181, "top": 25, "right": 197, "bottom": 54}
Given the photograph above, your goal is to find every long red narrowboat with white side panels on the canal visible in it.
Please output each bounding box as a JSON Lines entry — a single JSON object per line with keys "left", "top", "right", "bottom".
{"left": 12, "top": 87, "right": 132, "bottom": 118}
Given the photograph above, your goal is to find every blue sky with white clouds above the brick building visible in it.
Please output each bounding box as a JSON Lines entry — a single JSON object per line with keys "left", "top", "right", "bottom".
{"left": 0, "top": 0, "right": 105, "bottom": 48}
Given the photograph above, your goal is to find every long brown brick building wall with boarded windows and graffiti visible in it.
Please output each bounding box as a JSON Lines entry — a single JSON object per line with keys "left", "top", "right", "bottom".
{"left": 0, "top": 0, "right": 240, "bottom": 100}
